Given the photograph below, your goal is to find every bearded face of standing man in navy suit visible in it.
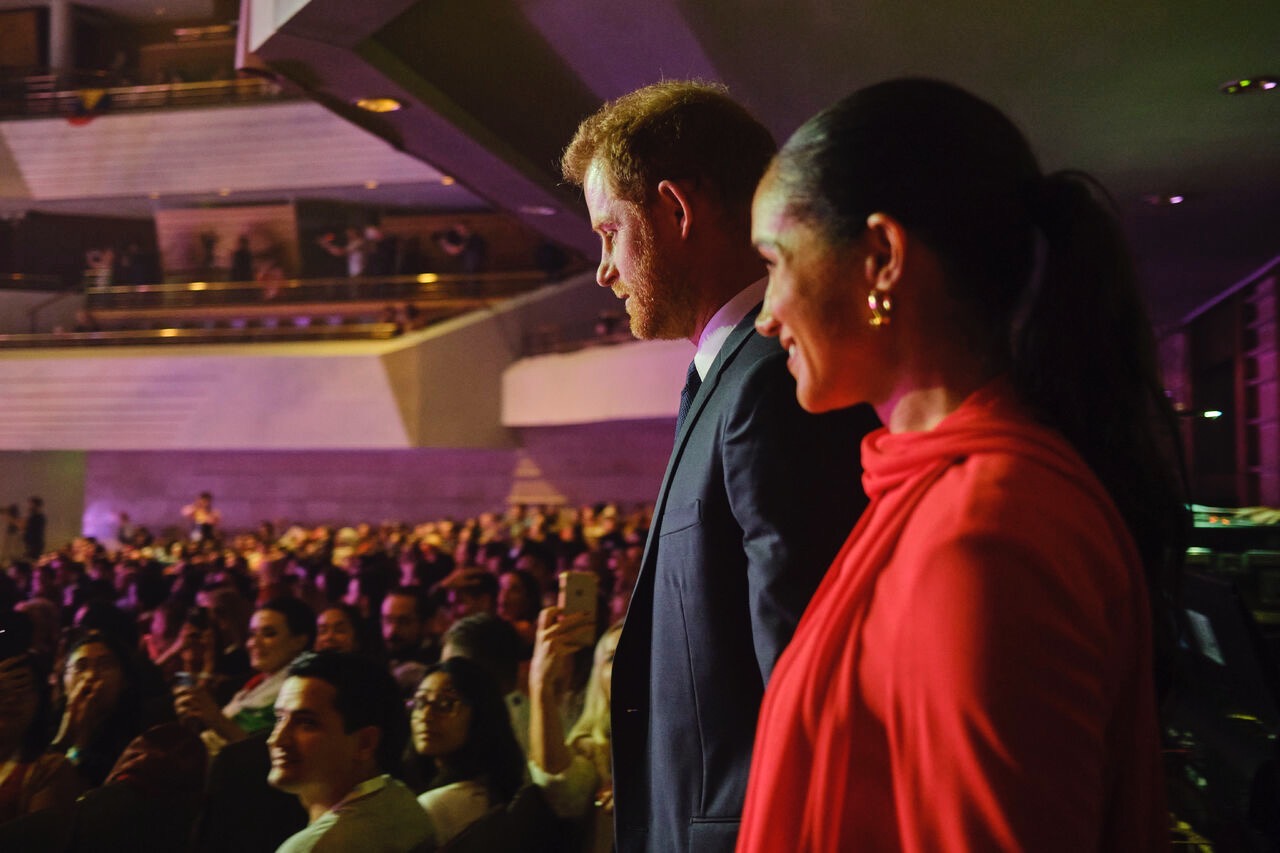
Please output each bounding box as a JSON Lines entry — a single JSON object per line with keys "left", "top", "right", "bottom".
{"left": 582, "top": 160, "right": 695, "bottom": 341}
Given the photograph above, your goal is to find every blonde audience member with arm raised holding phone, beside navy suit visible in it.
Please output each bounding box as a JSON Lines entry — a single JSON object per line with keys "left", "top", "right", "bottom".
{"left": 529, "top": 607, "right": 622, "bottom": 853}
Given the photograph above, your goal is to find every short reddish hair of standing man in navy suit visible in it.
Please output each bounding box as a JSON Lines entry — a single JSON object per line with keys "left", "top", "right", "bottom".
{"left": 561, "top": 79, "right": 777, "bottom": 214}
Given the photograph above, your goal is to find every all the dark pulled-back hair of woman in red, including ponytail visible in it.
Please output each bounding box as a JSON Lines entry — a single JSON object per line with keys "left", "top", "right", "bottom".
{"left": 774, "top": 79, "right": 1188, "bottom": 655}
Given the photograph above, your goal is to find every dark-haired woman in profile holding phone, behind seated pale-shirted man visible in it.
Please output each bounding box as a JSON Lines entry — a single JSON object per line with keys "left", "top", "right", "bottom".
{"left": 174, "top": 597, "right": 316, "bottom": 756}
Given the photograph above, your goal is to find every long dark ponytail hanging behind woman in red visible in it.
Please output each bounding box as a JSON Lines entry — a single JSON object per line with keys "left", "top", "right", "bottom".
{"left": 1012, "top": 172, "right": 1188, "bottom": 686}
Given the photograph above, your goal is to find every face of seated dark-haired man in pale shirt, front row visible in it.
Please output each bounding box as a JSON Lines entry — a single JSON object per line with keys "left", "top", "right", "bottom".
{"left": 266, "top": 675, "right": 361, "bottom": 802}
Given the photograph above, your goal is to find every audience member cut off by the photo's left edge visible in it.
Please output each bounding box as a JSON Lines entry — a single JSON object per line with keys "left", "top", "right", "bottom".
{"left": 0, "top": 613, "right": 83, "bottom": 824}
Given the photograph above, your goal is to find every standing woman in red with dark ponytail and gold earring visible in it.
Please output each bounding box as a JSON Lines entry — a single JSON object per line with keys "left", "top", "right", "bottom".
{"left": 739, "top": 79, "right": 1185, "bottom": 853}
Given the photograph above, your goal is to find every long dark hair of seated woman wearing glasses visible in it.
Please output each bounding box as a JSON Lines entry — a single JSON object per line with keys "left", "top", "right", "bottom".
{"left": 424, "top": 657, "right": 525, "bottom": 804}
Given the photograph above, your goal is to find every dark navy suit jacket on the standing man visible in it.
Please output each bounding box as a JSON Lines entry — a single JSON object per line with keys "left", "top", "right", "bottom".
{"left": 612, "top": 309, "right": 879, "bottom": 853}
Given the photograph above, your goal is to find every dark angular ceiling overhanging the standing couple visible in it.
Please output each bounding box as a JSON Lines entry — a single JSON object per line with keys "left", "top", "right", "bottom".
{"left": 242, "top": 0, "right": 1280, "bottom": 323}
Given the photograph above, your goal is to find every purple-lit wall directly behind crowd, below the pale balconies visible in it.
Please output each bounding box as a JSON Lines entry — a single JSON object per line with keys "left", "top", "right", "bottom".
{"left": 83, "top": 419, "right": 673, "bottom": 539}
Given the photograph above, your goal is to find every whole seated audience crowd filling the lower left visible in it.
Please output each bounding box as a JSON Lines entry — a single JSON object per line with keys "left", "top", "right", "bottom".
{"left": 0, "top": 496, "right": 649, "bottom": 852}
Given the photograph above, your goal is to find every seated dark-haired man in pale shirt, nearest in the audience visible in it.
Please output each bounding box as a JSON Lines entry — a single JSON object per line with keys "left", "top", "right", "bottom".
{"left": 268, "top": 652, "right": 431, "bottom": 853}
